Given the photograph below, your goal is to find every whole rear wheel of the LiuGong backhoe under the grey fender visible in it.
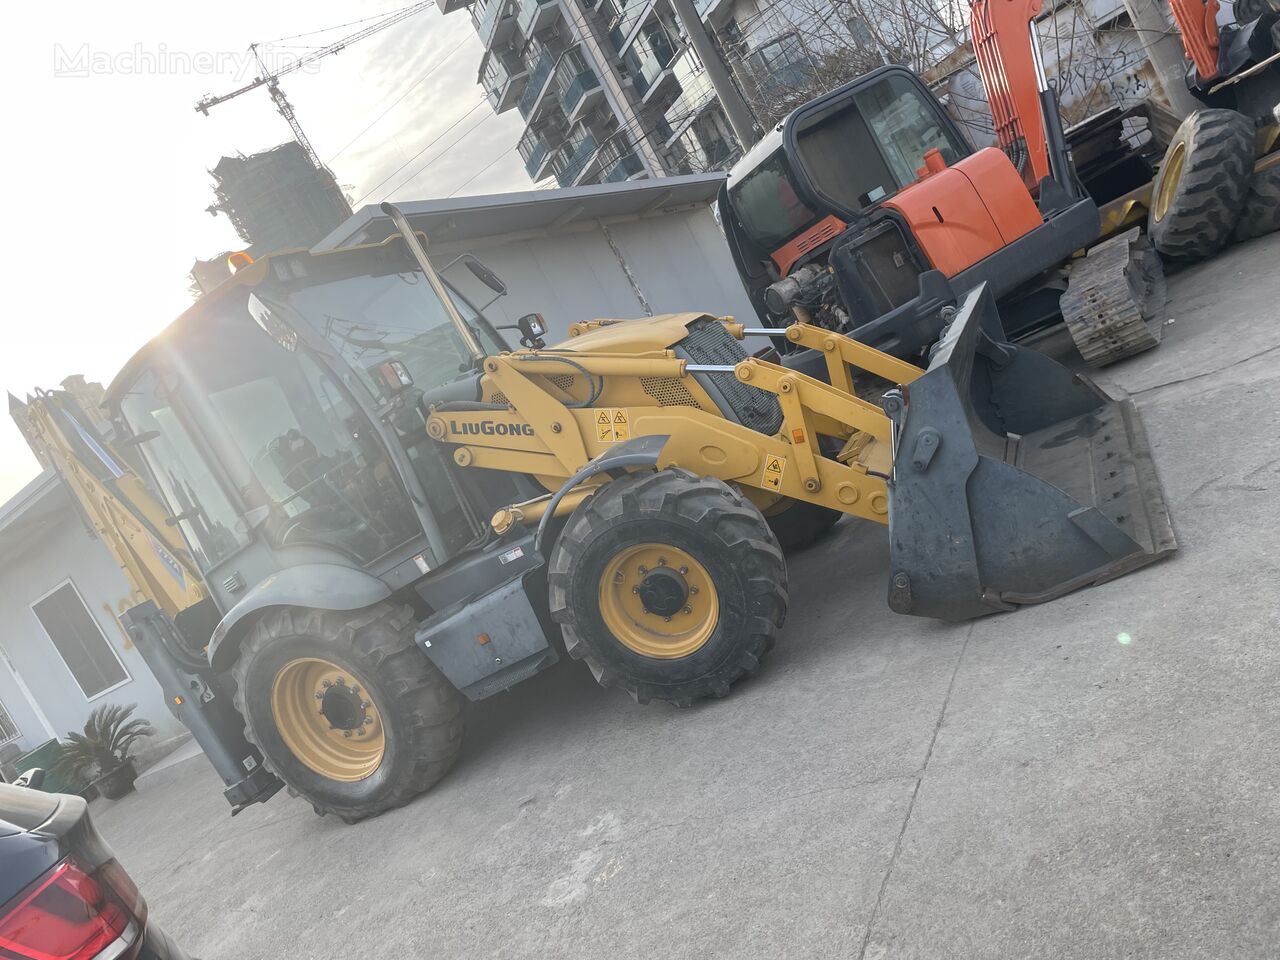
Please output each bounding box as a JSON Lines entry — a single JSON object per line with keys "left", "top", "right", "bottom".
{"left": 233, "top": 604, "right": 462, "bottom": 823}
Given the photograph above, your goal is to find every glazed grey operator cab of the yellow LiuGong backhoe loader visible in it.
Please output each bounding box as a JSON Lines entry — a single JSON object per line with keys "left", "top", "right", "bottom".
{"left": 109, "top": 239, "right": 520, "bottom": 609}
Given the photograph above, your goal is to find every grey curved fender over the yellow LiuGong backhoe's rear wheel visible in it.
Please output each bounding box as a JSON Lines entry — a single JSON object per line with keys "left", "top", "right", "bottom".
{"left": 209, "top": 563, "right": 392, "bottom": 673}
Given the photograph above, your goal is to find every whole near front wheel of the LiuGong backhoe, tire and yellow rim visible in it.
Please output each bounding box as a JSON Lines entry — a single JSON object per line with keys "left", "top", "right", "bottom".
{"left": 548, "top": 468, "right": 787, "bottom": 707}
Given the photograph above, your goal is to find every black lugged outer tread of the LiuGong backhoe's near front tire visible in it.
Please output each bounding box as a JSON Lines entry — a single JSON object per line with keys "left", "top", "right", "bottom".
{"left": 548, "top": 467, "right": 787, "bottom": 707}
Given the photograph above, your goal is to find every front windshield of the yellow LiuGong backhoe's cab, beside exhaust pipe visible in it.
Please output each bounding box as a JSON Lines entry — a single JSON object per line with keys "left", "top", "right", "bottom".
{"left": 284, "top": 271, "right": 504, "bottom": 394}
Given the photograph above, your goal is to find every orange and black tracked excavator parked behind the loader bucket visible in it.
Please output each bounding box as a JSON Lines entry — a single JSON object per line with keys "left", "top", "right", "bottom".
{"left": 719, "top": 0, "right": 1164, "bottom": 372}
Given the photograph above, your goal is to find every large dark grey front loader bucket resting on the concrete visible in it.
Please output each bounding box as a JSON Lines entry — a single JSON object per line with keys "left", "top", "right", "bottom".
{"left": 883, "top": 284, "right": 1178, "bottom": 620}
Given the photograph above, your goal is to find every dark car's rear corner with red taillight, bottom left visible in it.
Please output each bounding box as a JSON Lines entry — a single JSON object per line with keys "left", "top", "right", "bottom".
{"left": 0, "top": 783, "right": 188, "bottom": 960}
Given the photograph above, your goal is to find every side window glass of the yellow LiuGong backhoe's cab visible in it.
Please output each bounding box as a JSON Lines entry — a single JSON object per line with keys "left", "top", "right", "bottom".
{"left": 120, "top": 292, "right": 420, "bottom": 570}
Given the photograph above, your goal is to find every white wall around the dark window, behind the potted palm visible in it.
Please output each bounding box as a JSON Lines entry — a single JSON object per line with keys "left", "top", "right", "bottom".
{"left": 0, "top": 504, "right": 184, "bottom": 749}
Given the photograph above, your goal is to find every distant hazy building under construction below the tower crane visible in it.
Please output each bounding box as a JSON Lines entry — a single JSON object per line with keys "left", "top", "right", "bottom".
{"left": 209, "top": 140, "right": 351, "bottom": 252}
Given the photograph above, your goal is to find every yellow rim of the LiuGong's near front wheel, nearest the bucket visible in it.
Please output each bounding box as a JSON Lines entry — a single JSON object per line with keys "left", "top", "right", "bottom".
{"left": 600, "top": 543, "right": 719, "bottom": 660}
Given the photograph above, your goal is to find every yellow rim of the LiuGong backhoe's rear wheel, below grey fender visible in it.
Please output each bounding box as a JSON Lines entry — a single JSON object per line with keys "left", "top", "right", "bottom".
{"left": 271, "top": 657, "right": 387, "bottom": 783}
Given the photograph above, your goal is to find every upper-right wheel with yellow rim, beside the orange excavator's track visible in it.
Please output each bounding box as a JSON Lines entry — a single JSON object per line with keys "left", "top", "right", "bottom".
{"left": 1147, "top": 109, "right": 1254, "bottom": 261}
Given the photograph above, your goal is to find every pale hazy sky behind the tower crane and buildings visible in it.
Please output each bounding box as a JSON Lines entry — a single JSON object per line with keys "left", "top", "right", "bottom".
{"left": 0, "top": 0, "right": 532, "bottom": 502}
